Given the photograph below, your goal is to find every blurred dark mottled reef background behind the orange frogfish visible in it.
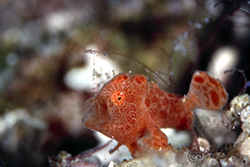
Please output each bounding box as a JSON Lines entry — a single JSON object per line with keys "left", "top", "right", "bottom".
{"left": 0, "top": 0, "right": 250, "bottom": 167}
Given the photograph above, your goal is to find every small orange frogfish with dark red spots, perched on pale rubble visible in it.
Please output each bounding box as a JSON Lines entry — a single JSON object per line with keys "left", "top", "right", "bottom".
{"left": 82, "top": 71, "right": 227, "bottom": 155}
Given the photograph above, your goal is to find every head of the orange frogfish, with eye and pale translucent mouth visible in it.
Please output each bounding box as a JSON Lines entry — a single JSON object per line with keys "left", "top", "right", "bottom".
{"left": 82, "top": 73, "right": 148, "bottom": 132}
